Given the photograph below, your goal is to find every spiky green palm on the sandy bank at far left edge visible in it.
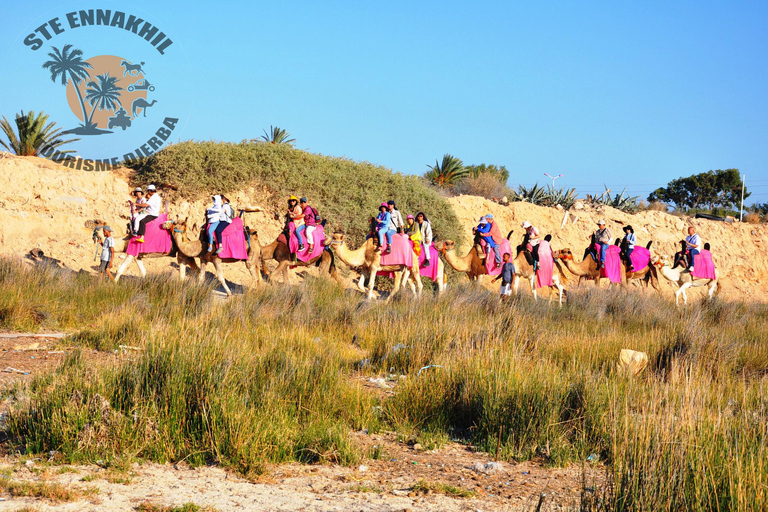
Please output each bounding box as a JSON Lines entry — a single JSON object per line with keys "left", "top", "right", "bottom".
{"left": 0, "top": 110, "right": 80, "bottom": 156}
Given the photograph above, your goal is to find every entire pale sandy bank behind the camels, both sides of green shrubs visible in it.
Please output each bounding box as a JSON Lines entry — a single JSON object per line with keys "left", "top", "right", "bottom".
{"left": 0, "top": 152, "right": 768, "bottom": 300}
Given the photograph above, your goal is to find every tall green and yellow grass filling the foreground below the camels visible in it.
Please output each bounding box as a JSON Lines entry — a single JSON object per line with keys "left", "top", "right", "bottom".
{"left": 0, "top": 262, "right": 768, "bottom": 510}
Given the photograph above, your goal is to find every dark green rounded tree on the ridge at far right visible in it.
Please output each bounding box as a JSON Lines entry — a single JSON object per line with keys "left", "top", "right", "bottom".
{"left": 648, "top": 169, "right": 750, "bottom": 210}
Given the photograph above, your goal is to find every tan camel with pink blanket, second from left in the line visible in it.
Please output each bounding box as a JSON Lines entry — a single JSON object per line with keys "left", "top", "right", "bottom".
{"left": 171, "top": 219, "right": 263, "bottom": 297}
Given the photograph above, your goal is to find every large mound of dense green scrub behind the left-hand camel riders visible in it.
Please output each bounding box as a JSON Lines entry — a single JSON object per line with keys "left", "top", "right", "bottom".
{"left": 127, "top": 141, "right": 462, "bottom": 245}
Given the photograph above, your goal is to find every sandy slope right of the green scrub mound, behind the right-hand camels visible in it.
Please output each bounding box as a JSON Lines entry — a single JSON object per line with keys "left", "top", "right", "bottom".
{"left": 448, "top": 196, "right": 768, "bottom": 300}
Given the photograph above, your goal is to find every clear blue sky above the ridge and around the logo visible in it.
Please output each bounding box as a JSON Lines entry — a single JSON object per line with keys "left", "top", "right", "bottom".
{"left": 0, "top": 0, "right": 768, "bottom": 202}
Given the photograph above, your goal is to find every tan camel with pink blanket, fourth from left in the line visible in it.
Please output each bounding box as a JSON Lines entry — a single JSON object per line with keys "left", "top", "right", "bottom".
{"left": 330, "top": 233, "right": 422, "bottom": 302}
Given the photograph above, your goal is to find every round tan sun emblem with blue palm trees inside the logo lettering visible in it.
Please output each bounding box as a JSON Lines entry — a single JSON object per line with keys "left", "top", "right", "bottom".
{"left": 43, "top": 44, "right": 157, "bottom": 135}
